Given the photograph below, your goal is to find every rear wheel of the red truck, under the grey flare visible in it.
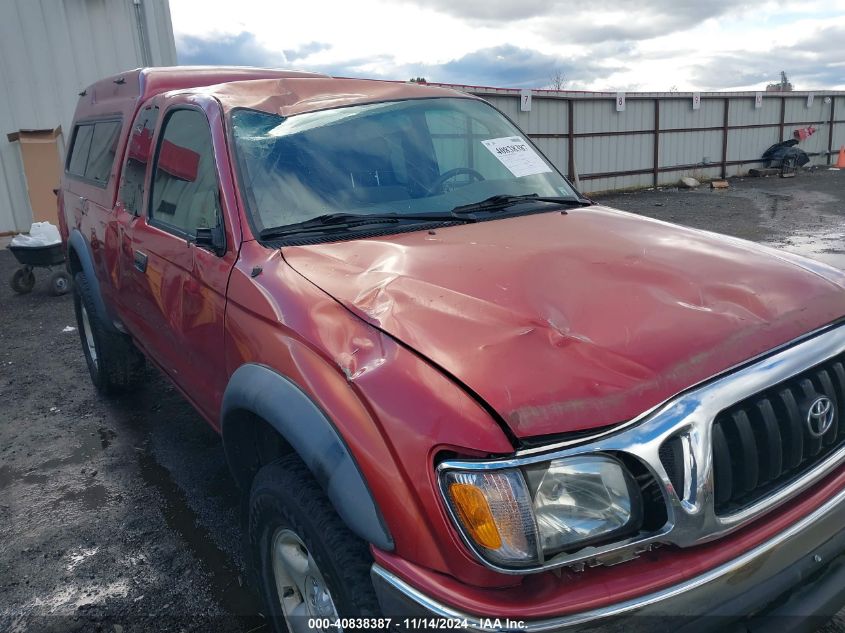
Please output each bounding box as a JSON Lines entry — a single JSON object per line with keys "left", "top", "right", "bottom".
{"left": 73, "top": 273, "right": 145, "bottom": 396}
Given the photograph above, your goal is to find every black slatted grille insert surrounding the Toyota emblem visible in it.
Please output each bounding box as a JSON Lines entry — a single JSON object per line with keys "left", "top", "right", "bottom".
{"left": 713, "top": 354, "right": 845, "bottom": 515}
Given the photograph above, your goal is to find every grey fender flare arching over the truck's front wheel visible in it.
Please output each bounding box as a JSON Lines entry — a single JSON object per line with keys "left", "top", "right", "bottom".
{"left": 221, "top": 363, "right": 394, "bottom": 551}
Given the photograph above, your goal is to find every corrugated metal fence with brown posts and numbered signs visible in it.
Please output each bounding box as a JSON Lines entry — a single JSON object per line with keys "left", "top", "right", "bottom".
{"left": 437, "top": 84, "right": 845, "bottom": 192}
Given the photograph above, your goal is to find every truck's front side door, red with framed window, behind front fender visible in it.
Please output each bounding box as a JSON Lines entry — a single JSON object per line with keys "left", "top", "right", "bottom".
{"left": 121, "top": 102, "right": 238, "bottom": 423}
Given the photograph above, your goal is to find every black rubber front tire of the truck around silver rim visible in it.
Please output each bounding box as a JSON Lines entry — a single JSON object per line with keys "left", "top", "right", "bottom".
{"left": 248, "top": 455, "right": 380, "bottom": 633}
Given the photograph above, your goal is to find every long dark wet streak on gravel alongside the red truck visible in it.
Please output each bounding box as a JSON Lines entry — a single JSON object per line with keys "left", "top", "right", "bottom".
{"left": 139, "top": 452, "right": 267, "bottom": 630}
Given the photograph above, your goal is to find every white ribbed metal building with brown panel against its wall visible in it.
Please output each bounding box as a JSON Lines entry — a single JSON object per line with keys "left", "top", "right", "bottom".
{"left": 0, "top": 0, "right": 176, "bottom": 235}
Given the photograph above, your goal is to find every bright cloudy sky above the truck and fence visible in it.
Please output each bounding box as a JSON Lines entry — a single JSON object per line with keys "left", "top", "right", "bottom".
{"left": 170, "top": 0, "right": 845, "bottom": 92}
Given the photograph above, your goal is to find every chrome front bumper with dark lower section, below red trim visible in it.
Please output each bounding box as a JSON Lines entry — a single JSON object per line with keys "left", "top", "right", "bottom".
{"left": 371, "top": 466, "right": 845, "bottom": 633}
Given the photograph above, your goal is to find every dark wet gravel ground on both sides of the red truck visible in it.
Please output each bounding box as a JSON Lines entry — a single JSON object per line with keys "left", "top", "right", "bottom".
{"left": 0, "top": 165, "right": 845, "bottom": 633}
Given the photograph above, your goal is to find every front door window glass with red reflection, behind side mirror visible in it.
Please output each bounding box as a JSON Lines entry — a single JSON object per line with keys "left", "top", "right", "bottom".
{"left": 150, "top": 110, "right": 221, "bottom": 237}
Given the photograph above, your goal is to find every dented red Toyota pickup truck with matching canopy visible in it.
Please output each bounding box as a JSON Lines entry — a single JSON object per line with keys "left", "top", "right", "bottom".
{"left": 59, "top": 68, "right": 845, "bottom": 631}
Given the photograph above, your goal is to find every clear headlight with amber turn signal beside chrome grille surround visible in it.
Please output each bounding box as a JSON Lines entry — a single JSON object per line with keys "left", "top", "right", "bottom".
{"left": 441, "top": 455, "right": 642, "bottom": 567}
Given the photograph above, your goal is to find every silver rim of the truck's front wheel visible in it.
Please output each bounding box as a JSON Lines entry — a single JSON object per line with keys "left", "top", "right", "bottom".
{"left": 271, "top": 528, "right": 341, "bottom": 633}
